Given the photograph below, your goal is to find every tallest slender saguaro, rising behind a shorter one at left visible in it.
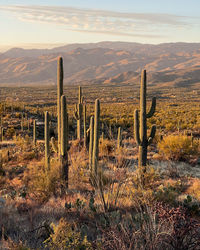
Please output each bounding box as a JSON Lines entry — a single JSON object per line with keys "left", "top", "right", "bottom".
{"left": 57, "top": 57, "right": 64, "bottom": 155}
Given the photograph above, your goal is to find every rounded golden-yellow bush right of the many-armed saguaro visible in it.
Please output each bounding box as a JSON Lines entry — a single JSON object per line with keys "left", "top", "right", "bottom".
{"left": 158, "top": 135, "right": 198, "bottom": 161}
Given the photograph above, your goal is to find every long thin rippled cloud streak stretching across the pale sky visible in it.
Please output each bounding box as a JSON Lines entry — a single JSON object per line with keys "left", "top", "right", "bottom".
{"left": 0, "top": 5, "right": 194, "bottom": 37}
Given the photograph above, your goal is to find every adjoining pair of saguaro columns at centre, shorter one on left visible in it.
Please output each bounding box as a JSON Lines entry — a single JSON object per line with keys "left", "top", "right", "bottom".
{"left": 89, "top": 99, "right": 100, "bottom": 175}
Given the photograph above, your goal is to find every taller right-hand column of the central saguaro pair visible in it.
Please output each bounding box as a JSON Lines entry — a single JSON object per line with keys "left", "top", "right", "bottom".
{"left": 92, "top": 99, "right": 100, "bottom": 176}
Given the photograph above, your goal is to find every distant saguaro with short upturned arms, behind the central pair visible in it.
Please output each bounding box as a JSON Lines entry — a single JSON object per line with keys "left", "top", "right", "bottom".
{"left": 74, "top": 86, "right": 83, "bottom": 140}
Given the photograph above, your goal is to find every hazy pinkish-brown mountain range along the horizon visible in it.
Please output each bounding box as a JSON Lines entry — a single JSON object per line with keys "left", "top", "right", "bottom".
{"left": 0, "top": 42, "right": 200, "bottom": 87}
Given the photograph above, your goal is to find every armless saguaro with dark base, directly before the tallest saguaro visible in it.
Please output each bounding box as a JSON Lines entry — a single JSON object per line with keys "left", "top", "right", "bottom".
{"left": 61, "top": 95, "right": 69, "bottom": 188}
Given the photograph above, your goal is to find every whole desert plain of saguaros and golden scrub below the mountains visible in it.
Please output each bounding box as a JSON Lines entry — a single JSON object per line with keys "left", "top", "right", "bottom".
{"left": 0, "top": 57, "right": 200, "bottom": 250}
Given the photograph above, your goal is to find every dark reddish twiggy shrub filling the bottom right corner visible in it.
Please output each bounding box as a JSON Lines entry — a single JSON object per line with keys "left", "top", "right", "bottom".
{"left": 101, "top": 203, "right": 200, "bottom": 250}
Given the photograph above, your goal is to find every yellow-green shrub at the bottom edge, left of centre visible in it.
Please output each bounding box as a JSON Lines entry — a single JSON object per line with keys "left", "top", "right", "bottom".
{"left": 45, "top": 218, "right": 93, "bottom": 250}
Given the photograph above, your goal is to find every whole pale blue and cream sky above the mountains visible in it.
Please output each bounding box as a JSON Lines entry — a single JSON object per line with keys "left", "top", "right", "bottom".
{"left": 0, "top": 0, "right": 200, "bottom": 51}
